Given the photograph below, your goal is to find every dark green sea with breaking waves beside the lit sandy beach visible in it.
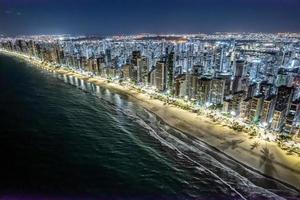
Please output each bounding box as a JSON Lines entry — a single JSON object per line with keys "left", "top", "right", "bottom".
{"left": 0, "top": 56, "right": 299, "bottom": 200}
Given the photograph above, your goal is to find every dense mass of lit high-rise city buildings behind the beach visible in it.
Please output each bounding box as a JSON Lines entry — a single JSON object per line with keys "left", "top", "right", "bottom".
{"left": 0, "top": 33, "right": 300, "bottom": 139}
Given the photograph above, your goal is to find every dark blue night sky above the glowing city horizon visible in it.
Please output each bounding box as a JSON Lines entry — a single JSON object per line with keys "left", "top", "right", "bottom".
{"left": 0, "top": 0, "right": 300, "bottom": 35}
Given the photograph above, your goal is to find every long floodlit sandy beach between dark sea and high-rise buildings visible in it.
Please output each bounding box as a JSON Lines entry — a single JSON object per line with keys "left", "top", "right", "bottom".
{"left": 0, "top": 50, "right": 300, "bottom": 190}
